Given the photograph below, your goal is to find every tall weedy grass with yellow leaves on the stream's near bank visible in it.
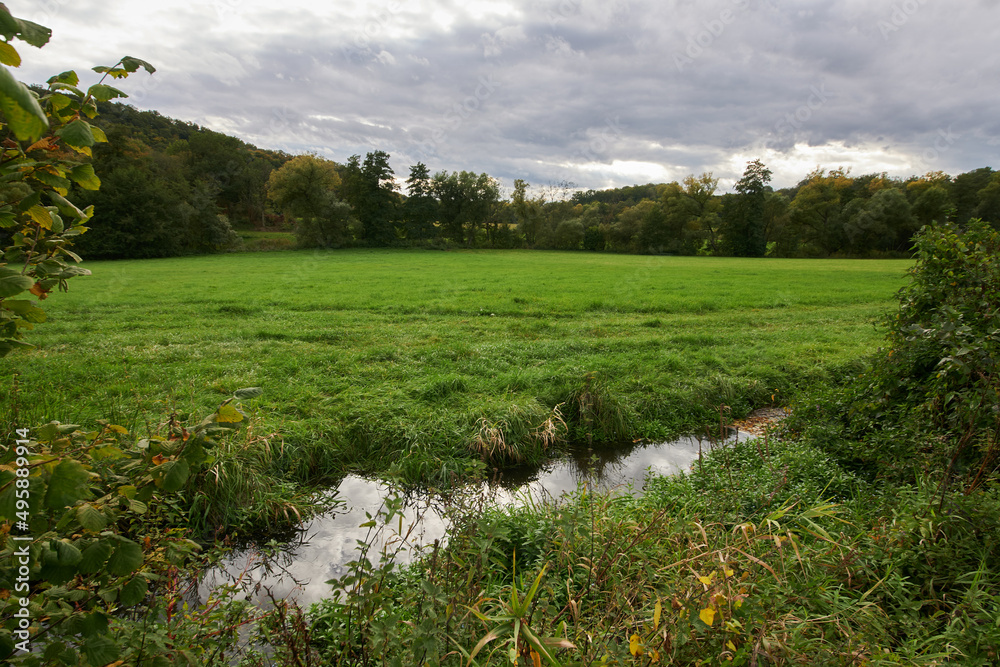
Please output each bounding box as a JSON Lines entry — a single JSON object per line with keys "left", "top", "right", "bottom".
{"left": 296, "top": 430, "right": 1000, "bottom": 665}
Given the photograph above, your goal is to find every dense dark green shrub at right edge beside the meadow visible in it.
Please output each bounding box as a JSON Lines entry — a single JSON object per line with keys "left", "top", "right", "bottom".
{"left": 793, "top": 220, "right": 1000, "bottom": 485}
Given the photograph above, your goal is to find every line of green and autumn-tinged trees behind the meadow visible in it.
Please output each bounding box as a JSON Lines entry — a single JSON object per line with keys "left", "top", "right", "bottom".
{"left": 72, "top": 103, "right": 1000, "bottom": 258}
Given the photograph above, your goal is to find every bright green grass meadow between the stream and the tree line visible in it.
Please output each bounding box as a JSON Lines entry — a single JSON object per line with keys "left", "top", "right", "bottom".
{"left": 0, "top": 251, "right": 909, "bottom": 486}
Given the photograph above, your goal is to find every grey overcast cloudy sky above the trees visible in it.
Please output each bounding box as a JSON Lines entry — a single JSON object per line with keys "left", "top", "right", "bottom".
{"left": 6, "top": 0, "right": 1000, "bottom": 189}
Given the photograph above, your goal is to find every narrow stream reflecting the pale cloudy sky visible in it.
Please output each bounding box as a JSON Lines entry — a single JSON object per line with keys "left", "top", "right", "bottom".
{"left": 198, "top": 432, "right": 750, "bottom": 608}
